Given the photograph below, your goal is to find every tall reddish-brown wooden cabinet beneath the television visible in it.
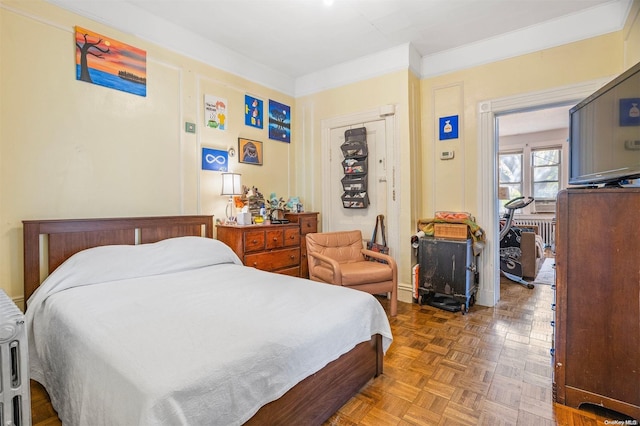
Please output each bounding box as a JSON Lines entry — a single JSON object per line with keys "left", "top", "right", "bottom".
{"left": 553, "top": 188, "right": 640, "bottom": 419}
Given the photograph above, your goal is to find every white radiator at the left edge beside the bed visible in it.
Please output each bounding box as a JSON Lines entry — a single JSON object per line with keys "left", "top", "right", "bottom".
{"left": 0, "top": 290, "right": 31, "bottom": 426}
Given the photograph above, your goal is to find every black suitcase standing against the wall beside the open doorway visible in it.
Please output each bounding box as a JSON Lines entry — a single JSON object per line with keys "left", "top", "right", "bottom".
{"left": 418, "top": 237, "right": 479, "bottom": 313}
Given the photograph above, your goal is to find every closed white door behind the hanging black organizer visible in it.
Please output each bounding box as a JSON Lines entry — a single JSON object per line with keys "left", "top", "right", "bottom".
{"left": 325, "top": 119, "right": 390, "bottom": 245}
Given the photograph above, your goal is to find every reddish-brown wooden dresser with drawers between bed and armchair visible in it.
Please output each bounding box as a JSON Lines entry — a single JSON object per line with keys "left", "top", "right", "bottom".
{"left": 216, "top": 213, "right": 317, "bottom": 277}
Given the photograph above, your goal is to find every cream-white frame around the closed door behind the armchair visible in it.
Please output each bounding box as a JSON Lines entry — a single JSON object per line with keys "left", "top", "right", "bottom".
{"left": 320, "top": 105, "right": 401, "bottom": 262}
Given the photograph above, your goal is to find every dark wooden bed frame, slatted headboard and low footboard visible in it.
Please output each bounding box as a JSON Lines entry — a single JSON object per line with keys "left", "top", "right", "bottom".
{"left": 23, "top": 216, "right": 383, "bottom": 425}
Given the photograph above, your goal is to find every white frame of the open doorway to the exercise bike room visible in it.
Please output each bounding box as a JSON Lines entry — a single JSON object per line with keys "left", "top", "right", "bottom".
{"left": 477, "top": 78, "right": 611, "bottom": 306}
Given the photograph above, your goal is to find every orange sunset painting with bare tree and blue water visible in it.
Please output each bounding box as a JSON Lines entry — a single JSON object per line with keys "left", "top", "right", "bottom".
{"left": 76, "top": 27, "right": 147, "bottom": 96}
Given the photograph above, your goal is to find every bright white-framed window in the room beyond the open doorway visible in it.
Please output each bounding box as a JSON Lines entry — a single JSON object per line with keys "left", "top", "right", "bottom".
{"left": 498, "top": 146, "right": 562, "bottom": 214}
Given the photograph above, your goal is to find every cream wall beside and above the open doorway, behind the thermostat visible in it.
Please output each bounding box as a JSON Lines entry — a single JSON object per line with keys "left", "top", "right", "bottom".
{"left": 421, "top": 32, "right": 623, "bottom": 220}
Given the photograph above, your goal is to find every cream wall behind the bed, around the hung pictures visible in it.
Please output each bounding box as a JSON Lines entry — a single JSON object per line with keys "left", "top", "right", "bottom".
{"left": 0, "top": 0, "right": 294, "bottom": 301}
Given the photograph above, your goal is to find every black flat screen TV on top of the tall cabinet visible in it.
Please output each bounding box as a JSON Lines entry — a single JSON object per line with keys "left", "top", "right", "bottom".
{"left": 569, "top": 63, "right": 640, "bottom": 185}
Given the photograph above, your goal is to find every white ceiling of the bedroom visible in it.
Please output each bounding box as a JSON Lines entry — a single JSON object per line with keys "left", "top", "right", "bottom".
{"left": 49, "top": 0, "right": 631, "bottom": 79}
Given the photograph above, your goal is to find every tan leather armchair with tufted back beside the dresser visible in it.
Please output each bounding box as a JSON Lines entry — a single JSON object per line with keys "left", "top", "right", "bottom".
{"left": 306, "top": 230, "right": 398, "bottom": 316}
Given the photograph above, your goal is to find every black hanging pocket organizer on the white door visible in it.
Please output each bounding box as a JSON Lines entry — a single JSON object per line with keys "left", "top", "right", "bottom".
{"left": 340, "top": 127, "right": 369, "bottom": 209}
